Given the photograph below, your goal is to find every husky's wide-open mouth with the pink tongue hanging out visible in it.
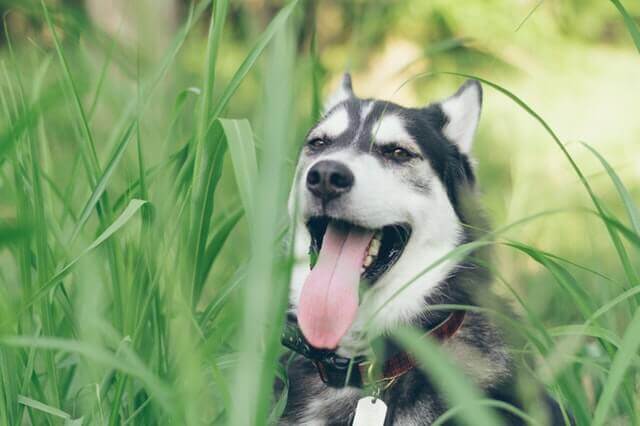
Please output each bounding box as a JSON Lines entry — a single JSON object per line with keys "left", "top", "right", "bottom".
{"left": 298, "top": 216, "right": 411, "bottom": 349}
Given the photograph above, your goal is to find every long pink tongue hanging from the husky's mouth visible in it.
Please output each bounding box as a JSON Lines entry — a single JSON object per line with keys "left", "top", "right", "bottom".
{"left": 298, "top": 223, "right": 373, "bottom": 349}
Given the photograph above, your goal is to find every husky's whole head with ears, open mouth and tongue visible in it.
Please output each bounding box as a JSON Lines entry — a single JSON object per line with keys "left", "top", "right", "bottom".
{"left": 290, "top": 75, "right": 482, "bottom": 354}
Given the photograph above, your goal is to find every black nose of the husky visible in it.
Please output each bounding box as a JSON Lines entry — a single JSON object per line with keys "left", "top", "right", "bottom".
{"left": 307, "top": 160, "right": 354, "bottom": 201}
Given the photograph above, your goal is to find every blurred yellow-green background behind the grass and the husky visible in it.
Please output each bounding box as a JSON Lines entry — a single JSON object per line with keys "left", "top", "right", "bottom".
{"left": 0, "top": 0, "right": 640, "bottom": 424}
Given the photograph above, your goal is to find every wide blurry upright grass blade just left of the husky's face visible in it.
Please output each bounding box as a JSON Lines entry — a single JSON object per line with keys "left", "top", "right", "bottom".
{"left": 230, "top": 15, "right": 296, "bottom": 426}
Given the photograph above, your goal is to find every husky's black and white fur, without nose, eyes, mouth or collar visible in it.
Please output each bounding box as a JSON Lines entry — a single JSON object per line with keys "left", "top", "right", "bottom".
{"left": 280, "top": 75, "right": 564, "bottom": 426}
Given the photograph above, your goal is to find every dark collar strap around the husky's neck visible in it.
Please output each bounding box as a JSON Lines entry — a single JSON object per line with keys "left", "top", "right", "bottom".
{"left": 282, "top": 311, "right": 465, "bottom": 388}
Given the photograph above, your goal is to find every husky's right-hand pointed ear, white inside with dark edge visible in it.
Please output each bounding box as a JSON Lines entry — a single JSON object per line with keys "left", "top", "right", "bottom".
{"left": 440, "top": 80, "right": 482, "bottom": 154}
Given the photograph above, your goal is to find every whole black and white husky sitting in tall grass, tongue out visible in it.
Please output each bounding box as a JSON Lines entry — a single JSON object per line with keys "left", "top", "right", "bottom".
{"left": 280, "top": 74, "right": 558, "bottom": 426}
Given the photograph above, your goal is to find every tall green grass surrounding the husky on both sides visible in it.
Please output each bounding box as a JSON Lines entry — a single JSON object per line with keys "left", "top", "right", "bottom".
{"left": 0, "top": 0, "right": 640, "bottom": 426}
